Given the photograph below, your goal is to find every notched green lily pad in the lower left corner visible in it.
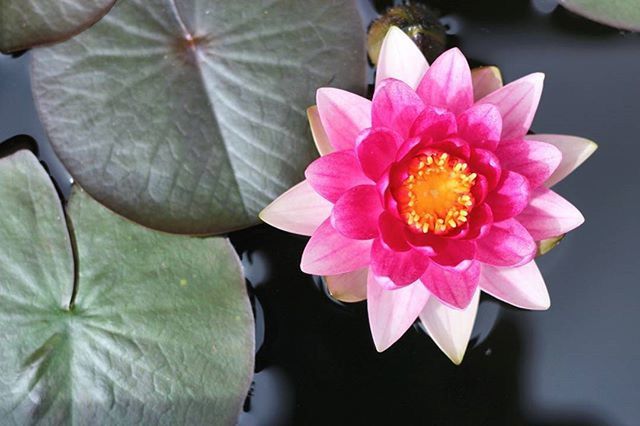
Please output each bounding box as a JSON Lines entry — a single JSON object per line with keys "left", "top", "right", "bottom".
{"left": 0, "top": 151, "right": 254, "bottom": 425}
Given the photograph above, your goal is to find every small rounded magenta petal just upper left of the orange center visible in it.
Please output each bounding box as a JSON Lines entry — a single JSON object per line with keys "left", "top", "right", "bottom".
{"left": 356, "top": 128, "right": 402, "bottom": 181}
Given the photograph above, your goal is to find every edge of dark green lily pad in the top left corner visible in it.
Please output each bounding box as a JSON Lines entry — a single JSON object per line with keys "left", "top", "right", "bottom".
{"left": 0, "top": 0, "right": 116, "bottom": 53}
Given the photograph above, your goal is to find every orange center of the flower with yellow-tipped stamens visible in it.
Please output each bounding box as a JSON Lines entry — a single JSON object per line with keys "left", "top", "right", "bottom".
{"left": 398, "top": 152, "right": 477, "bottom": 234}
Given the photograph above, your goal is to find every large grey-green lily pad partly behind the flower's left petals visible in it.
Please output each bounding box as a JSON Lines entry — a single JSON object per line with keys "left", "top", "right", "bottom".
{"left": 32, "top": 0, "right": 366, "bottom": 234}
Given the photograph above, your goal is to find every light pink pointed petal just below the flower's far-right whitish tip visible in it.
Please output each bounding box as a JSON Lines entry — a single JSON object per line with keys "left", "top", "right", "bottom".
{"left": 517, "top": 187, "right": 584, "bottom": 241}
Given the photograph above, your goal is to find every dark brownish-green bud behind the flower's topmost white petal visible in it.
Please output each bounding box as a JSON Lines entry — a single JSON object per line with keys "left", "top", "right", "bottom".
{"left": 367, "top": 3, "right": 447, "bottom": 65}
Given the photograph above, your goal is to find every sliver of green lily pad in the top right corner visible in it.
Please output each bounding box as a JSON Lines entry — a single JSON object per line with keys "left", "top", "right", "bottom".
{"left": 560, "top": 0, "right": 640, "bottom": 31}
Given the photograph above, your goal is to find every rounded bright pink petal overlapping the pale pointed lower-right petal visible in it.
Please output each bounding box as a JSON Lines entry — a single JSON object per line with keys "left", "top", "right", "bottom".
{"left": 476, "top": 219, "right": 537, "bottom": 267}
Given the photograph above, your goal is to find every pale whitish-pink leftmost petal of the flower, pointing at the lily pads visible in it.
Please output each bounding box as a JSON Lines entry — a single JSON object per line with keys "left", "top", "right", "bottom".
{"left": 260, "top": 180, "right": 333, "bottom": 235}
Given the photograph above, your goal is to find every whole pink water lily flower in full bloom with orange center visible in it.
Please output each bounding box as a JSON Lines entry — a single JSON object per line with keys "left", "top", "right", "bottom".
{"left": 261, "top": 28, "right": 596, "bottom": 364}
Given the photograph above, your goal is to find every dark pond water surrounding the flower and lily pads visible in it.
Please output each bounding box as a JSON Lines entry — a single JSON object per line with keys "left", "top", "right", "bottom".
{"left": 0, "top": 0, "right": 640, "bottom": 426}
